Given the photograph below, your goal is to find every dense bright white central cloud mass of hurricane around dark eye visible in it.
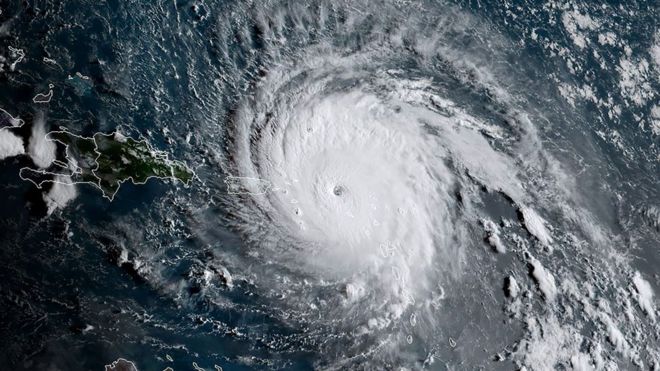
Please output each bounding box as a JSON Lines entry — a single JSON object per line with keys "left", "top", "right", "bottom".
{"left": 226, "top": 10, "right": 540, "bottom": 360}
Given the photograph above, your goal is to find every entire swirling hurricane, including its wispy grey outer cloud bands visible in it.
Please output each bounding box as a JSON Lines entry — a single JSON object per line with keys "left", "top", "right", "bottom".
{"left": 187, "top": 2, "right": 660, "bottom": 369}
